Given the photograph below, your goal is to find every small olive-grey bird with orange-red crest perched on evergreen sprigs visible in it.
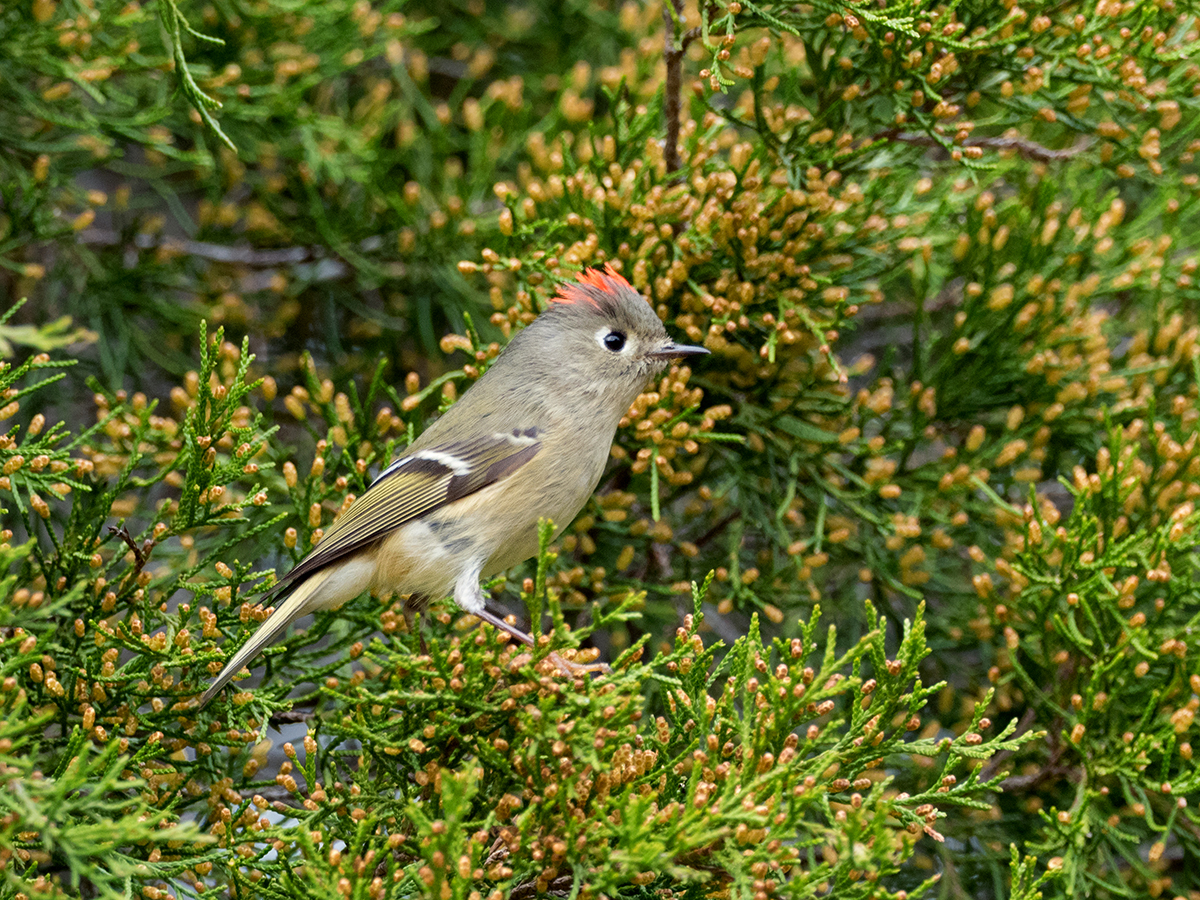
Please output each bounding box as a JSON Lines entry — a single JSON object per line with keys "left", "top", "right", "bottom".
{"left": 200, "top": 265, "right": 708, "bottom": 707}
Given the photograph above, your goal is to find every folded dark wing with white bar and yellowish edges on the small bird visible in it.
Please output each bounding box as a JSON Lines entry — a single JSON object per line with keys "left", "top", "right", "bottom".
{"left": 272, "top": 428, "right": 542, "bottom": 593}
